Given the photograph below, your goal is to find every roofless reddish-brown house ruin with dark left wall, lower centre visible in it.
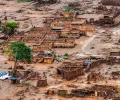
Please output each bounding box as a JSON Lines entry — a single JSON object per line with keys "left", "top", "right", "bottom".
{"left": 57, "top": 61, "right": 84, "bottom": 80}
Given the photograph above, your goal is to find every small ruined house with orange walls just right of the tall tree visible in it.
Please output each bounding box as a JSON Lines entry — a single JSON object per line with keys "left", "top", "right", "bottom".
{"left": 33, "top": 51, "right": 55, "bottom": 64}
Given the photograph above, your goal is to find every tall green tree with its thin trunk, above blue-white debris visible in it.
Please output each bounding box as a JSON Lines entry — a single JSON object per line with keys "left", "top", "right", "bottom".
{"left": 6, "top": 42, "right": 32, "bottom": 84}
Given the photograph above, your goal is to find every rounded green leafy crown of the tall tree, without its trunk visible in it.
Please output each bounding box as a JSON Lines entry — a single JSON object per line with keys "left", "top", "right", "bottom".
{"left": 6, "top": 42, "right": 32, "bottom": 63}
